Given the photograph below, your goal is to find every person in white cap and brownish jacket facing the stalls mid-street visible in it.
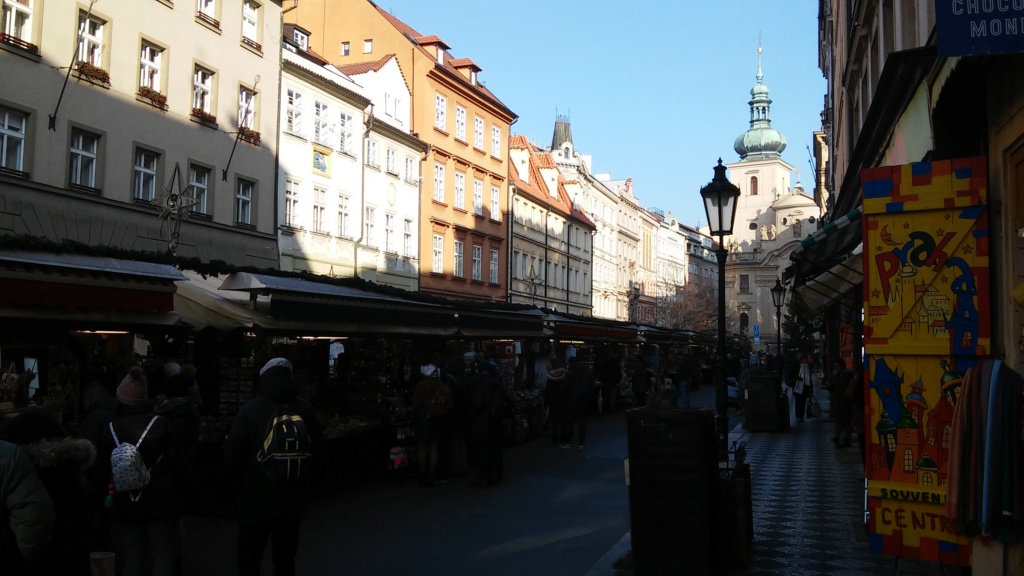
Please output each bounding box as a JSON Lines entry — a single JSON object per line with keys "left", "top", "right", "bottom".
{"left": 413, "top": 364, "right": 452, "bottom": 488}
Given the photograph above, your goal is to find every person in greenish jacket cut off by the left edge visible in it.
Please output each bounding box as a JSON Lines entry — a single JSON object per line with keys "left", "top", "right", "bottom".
{"left": 0, "top": 441, "right": 54, "bottom": 576}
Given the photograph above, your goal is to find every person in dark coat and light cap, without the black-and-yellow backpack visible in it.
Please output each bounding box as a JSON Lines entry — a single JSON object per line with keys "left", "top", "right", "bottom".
{"left": 224, "top": 358, "right": 324, "bottom": 576}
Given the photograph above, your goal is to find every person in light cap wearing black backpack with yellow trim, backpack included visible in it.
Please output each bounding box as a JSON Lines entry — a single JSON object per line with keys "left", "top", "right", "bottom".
{"left": 224, "top": 358, "right": 324, "bottom": 576}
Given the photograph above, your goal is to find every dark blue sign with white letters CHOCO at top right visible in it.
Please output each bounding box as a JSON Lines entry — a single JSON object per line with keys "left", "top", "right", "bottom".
{"left": 935, "top": 0, "right": 1024, "bottom": 56}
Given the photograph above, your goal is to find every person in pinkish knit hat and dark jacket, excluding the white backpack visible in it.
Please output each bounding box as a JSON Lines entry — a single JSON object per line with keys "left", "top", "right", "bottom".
{"left": 96, "top": 366, "right": 200, "bottom": 576}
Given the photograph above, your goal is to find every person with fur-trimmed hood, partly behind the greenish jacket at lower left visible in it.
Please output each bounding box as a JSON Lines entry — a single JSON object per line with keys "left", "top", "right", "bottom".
{"left": 3, "top": 408, "right": 99, "bottom": 576}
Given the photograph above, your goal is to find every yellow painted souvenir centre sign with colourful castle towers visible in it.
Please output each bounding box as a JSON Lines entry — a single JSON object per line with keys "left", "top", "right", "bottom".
{"left": 861, "top": 158, "right": 991, "bottom": 566}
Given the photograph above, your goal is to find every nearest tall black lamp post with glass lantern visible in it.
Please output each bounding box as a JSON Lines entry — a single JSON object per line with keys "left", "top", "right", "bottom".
{"left": 700, "top": 158, "right": 739, "bottom": 460}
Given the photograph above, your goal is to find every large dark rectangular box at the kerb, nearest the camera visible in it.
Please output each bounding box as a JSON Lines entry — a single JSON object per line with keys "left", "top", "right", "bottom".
{"left": 626, "top": 408, "right": 719, "bottom": 576}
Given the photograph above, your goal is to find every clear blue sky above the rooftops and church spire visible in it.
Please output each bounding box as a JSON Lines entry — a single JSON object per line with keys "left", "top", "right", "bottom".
{"left": 377, "top": 0, "right": 825, "bottom": 225}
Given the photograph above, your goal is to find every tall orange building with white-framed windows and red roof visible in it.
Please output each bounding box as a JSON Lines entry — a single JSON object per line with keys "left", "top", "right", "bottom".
{"left": 284, "top": 0, "right": 516, "bottom": 300}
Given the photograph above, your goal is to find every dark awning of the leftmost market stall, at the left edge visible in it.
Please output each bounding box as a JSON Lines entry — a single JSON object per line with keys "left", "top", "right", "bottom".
{"left": 0, "top": 250, "right": 185, "bottom": 329}
